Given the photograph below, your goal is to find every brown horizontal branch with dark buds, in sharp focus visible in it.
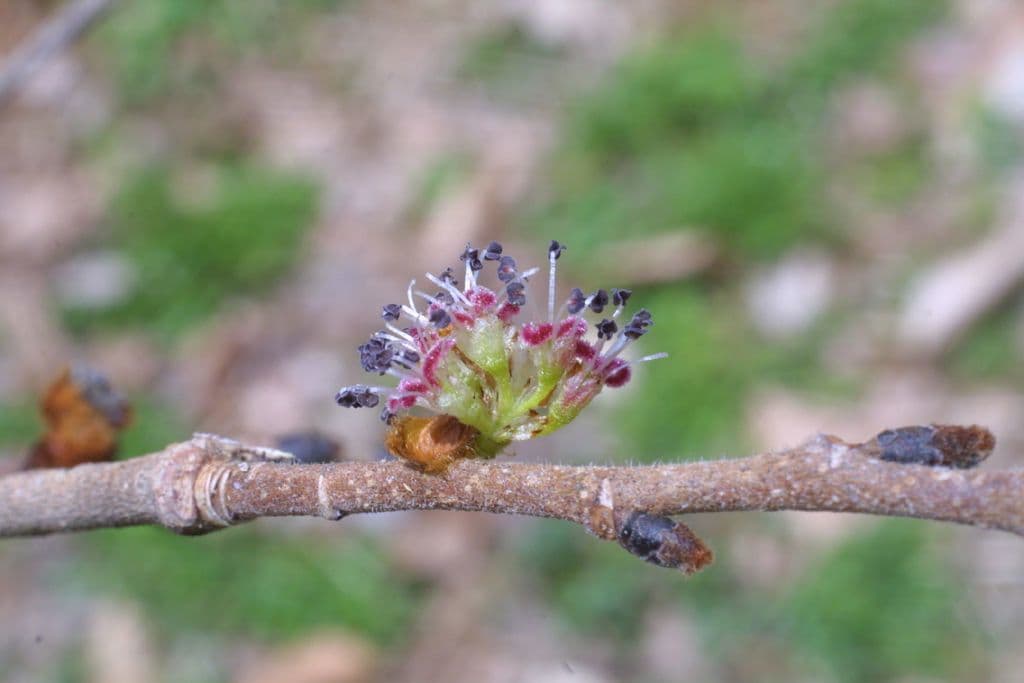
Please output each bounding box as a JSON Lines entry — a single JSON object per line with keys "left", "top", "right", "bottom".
{"left": 0, "top": 428, "right": 1024, "bottom": 570}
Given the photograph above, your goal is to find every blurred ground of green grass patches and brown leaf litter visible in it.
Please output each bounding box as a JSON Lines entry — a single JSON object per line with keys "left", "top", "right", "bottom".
{"left": 0, "top": 0, "right": 1024, "bottom": 683}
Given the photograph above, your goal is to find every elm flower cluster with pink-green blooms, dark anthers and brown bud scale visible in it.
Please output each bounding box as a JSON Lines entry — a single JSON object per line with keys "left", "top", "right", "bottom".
{"left": 335, "top": 241, "right": 668, "bottom": 471}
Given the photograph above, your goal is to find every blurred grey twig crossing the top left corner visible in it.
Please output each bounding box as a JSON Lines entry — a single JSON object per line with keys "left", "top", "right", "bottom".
{"left": 0, "top": 0, "right": 113, "bottom": 106}
